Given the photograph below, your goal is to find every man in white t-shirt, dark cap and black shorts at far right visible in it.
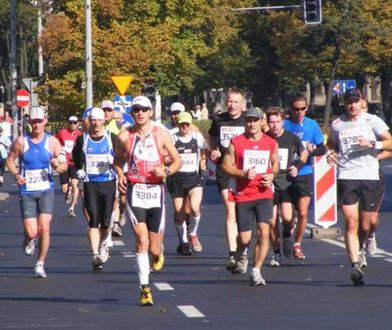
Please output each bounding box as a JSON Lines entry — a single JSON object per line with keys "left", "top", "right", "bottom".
{"left": 328, "top": 89, "right": 392, "bottom": 285}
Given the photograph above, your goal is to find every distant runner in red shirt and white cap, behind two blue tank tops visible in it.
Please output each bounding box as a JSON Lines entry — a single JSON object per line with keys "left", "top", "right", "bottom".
{"left": 56, "top": 116, "right": 82, "bottom": 217}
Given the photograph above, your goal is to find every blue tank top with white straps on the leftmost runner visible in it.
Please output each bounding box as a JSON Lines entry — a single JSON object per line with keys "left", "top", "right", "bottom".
{"left": 19, "top": 133, "right": 54, "bottom": 195}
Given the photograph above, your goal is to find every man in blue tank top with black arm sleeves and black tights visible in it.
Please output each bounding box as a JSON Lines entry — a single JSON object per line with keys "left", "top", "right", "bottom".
{"left": 72, "top": 108, "right": 116, "bottom": 271}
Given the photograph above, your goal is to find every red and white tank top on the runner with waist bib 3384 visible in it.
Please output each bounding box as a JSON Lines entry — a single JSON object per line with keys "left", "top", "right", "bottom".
{"left": 127, "top": 126, "right": 163, "bottom": 184}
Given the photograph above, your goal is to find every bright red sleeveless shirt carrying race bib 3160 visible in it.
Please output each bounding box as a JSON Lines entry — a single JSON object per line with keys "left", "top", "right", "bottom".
{"left": 231, "top": 134, "right": 276, "bottom": 203}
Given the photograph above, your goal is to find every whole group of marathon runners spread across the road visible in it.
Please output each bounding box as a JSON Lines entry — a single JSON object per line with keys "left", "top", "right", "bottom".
{"left": 7, "top": 89, "right": 392, "bottom": 305}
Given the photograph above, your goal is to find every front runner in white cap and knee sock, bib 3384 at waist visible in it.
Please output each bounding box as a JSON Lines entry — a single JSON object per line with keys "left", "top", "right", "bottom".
{"left": 114, "top": 96, "right": 181, "bottom": 306}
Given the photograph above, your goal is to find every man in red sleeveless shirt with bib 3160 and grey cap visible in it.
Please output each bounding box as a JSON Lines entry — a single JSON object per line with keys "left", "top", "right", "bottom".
{"left": 222, "top": 108, "right": 279, "bottom": 285}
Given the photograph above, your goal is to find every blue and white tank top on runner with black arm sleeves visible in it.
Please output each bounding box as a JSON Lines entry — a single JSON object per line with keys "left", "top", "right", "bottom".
{"left": 83, "top": 131, "right": 115, "bottom": 182}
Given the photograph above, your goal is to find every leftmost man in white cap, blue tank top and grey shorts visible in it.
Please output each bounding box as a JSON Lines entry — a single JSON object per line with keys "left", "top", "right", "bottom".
{"left": 7, "top": 107, "right": 67, "bottom": 278}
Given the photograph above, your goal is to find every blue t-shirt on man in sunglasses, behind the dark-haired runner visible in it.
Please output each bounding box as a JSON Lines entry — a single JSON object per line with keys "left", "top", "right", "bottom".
{"left": 283, "top": 117, "right": 324, "bottom": 175}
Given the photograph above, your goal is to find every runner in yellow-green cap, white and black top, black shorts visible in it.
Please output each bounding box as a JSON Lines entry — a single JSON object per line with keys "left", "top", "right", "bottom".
{"left": 167, "top": 112, "right": 207, "bottom": 255}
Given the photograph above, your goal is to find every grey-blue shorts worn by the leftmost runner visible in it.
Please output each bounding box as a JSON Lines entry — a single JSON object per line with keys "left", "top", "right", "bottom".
{"left": 19, "top": 190, "right": 54, "bottom": 220}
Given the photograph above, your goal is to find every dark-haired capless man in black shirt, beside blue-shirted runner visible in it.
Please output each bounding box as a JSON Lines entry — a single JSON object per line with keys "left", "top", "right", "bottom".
{"left": 267, "top": 107, "right": 308, "bottom": 267}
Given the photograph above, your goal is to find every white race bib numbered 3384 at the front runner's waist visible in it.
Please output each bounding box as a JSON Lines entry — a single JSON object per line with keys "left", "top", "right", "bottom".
{"left": 132, "top": 183, "right": 162, "bottom": 209}
